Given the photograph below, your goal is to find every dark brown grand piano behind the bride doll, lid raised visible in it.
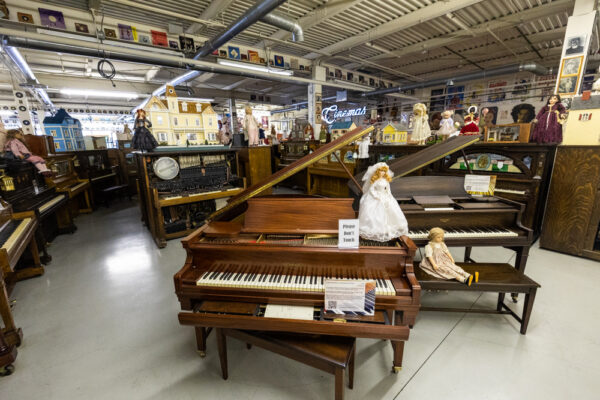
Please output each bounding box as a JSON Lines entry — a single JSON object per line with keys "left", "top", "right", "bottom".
{"left": 348, "top": 136, "right": 533, "bottom": 294}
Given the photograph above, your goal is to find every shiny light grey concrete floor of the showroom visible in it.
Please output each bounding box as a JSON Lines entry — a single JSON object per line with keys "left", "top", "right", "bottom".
{"left": 0, "top": 202, "right": 600, "bottom": 400}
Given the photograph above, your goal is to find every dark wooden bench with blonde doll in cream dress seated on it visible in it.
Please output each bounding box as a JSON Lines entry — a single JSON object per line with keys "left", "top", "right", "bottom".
{"left": 415, "top": 262, "right": 540, "bottom": 335}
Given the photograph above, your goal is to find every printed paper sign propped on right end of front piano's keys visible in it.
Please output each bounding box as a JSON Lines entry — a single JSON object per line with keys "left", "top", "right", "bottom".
{"left": 325, "top": 279, "right": 376, "bottom": 315}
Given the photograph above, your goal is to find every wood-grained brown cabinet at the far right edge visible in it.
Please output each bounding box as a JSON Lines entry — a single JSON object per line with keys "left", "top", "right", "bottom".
{"left": 540, "top": 146, "right": 600, "bottom": 261}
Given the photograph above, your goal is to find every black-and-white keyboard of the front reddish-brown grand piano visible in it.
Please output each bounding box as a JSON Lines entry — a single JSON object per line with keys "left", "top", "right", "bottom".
{"left": 196, "top": 265, "right": 396, "bottom": 296}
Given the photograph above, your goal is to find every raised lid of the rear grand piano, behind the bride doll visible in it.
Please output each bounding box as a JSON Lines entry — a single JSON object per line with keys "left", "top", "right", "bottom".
{"left": 348, "top": 135, "right": 481, "bottom": 195}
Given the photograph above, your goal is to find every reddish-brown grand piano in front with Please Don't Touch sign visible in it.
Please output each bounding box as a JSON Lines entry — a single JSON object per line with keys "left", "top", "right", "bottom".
{"left": 174, "top": 128, "right": 421, "bottom": 371}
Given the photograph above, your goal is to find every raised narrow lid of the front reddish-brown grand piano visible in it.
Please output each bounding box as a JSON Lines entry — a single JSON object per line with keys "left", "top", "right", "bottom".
{"left": 207, "top": 126, "right": 374, "bottom": 221}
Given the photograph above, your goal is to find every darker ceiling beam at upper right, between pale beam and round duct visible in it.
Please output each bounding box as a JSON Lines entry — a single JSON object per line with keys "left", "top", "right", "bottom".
{"left": 369, "top": 0, "right": 573, "bottom": 61}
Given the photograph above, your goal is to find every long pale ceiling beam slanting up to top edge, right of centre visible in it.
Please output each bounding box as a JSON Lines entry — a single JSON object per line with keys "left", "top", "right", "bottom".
{"left": 305, "top": 0, "right": 482, "bottom": 58}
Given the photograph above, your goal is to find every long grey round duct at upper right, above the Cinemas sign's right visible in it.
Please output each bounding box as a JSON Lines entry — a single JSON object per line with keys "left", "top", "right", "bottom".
{"left": 362, "top": 63, "right": 548, "bottom": 96}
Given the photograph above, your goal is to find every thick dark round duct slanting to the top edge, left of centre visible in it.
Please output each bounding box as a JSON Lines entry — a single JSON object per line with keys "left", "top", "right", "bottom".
{"left": 194, "top": 0, "right": 286, "bottom": 60}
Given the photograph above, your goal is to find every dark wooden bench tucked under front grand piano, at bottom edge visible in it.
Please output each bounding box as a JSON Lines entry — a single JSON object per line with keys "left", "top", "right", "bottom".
{"left": 215, "top": 328, "right": 356, "bottom": 400}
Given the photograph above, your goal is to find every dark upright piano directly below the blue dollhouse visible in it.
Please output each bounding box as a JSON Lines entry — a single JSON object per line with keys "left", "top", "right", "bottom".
{"left": 46, "top": 153, "right": 92, "bottom": 217}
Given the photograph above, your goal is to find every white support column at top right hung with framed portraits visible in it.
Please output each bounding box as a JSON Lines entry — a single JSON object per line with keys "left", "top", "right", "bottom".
{"left": 555, "top": 0, "right": 597, "bottom": 97}
